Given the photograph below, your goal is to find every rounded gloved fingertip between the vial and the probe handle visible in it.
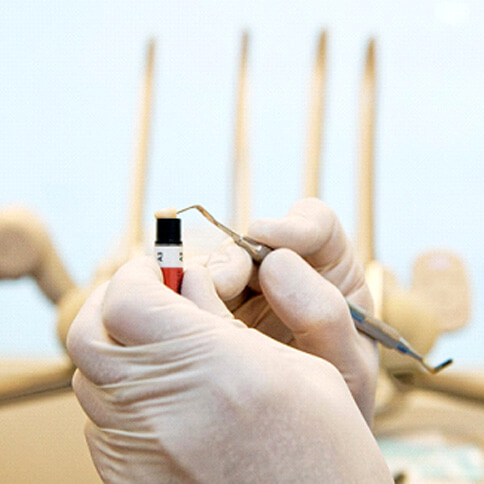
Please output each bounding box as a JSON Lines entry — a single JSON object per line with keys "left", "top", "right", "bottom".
{"left": 206, "top": 241, "right": 253, "bottom": 301}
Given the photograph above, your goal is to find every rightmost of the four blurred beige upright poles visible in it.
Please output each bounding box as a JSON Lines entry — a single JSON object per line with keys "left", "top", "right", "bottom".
{"left": 356, "top": 39, "right": 376, "bottom": 267}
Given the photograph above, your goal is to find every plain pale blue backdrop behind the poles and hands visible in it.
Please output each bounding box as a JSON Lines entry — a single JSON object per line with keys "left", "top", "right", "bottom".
{"left": 0, "top": 0, "right": 484, "bottom": 366}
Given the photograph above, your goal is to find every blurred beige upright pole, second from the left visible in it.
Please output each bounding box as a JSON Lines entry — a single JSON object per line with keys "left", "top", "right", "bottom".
{"left": 232, "top": 32, "right": 251, "bottom": 233}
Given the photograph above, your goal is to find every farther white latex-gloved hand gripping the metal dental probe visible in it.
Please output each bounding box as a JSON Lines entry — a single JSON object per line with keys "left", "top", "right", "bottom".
{"left": 207, "top": 198, "right": 378, "bottom": 424}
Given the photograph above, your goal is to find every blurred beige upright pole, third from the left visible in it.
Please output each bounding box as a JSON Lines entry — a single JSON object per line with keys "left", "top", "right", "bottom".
{"left": 303, "top": 32, "right": 327, "bottom": 198}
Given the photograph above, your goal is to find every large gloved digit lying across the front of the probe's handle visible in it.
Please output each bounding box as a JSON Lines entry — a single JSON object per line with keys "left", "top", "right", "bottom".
{"left": 259, "top": 249, "right": 372, "bottom": 380}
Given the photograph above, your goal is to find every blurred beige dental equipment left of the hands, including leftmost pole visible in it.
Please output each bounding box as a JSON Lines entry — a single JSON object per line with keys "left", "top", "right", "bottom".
{"left": 0, "top": 41, "right": 155, "bottom": 484}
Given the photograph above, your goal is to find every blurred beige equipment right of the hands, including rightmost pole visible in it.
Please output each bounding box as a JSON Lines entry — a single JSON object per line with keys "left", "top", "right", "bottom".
{"left": 357, "top": 36, "right": 484, "bottom": 483}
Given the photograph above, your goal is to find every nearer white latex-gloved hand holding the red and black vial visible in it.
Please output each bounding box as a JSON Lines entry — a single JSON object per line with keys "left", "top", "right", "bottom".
{"left": 67, "top": 257, "right": 392, "bottom": 484}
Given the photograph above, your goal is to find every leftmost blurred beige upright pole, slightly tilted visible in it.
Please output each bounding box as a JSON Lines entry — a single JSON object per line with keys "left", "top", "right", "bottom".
{"left": 126, "top": 40, "right": 155, "bottom": 253}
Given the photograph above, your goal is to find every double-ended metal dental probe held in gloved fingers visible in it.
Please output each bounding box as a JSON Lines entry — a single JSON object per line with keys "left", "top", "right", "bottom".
{"left": 177, "top": 205, "right": 452, "bottom": 374}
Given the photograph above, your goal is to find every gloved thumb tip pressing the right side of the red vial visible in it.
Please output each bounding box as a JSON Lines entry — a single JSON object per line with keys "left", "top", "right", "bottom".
{"left": 181, "top": 265, "right": 245, "bottom": 327}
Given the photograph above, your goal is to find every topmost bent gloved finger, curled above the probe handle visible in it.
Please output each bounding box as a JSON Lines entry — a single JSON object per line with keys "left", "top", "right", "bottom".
{"left": 248, "top": 198, "right": 364, "bottom": 296}
